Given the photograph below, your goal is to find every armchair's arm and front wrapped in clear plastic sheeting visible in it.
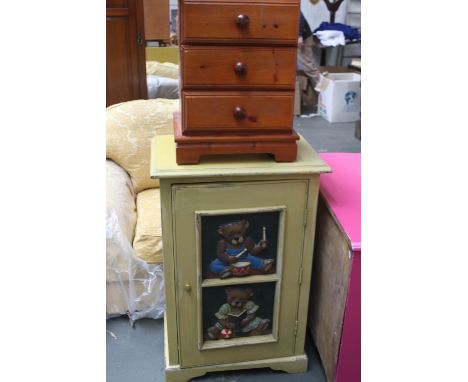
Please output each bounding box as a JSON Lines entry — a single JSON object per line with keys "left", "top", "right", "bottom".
{"left": 106, "top": 160, "right": 165, "bottom": 321}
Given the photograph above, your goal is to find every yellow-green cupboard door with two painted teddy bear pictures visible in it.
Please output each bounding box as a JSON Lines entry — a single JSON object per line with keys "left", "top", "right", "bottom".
{"left": 172, "top": 180, "right": 308, "bottom": 367}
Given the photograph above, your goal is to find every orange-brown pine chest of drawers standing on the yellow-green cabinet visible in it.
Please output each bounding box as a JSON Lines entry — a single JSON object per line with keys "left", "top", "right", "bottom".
{"left": 174, "top": 0, "right": 299, "bottom": 164}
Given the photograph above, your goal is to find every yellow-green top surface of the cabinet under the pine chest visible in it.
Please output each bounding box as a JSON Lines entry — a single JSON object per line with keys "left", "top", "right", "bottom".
{"left": 150, "top": 135, "right": 331, "bottom": 178}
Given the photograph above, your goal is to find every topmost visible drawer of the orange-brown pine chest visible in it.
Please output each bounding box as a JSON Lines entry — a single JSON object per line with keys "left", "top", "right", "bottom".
{"left": 180, "top": 0, "right": 299, "bottom": 45}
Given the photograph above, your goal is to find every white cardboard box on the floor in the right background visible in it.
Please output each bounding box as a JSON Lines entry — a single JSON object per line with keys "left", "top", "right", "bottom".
{"left": 318, "top": 73, "right": 361, "bottom": 123}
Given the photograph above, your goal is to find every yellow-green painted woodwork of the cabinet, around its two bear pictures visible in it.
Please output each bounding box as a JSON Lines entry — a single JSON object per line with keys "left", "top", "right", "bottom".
{"left": 151, "top": 136, "right": 330, "bottom": 382}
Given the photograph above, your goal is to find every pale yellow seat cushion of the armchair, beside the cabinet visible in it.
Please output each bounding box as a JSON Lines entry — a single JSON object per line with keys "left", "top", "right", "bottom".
{"left": 133, "top": 188, "right": 163, "bottom": 263}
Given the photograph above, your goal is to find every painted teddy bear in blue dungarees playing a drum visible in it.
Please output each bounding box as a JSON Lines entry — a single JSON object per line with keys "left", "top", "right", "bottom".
{"left": 210, "top": 220, "right": 273, "bottom": 279}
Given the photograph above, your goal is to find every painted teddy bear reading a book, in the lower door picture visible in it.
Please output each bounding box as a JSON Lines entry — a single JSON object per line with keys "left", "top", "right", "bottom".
{"left": 208, "top": 287, "right": 270, "bottom": 340}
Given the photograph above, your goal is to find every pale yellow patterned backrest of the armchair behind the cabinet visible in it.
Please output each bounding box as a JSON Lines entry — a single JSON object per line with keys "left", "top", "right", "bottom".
{"left": 106, "top": 98, "right": 180, "bottom": 193}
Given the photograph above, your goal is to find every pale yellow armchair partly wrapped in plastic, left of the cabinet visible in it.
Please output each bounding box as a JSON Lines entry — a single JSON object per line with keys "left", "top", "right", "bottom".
{"left": 106, "top": 99, "right": 179, "bottom": 320}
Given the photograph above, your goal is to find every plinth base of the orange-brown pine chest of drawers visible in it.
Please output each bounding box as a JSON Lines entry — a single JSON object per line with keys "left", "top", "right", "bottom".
{"left": 174, "top": 112, "right": 299, "bottom": 164}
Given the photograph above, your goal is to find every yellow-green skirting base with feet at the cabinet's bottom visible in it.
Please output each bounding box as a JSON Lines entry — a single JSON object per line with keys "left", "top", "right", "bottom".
{"left": 166, "top": 354, "right": 308, "bottom": 382}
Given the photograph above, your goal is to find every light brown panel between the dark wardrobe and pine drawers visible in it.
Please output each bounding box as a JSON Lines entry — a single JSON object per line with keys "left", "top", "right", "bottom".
{"left": 143, "top": 0, "right": 170, "bottom": 41}
